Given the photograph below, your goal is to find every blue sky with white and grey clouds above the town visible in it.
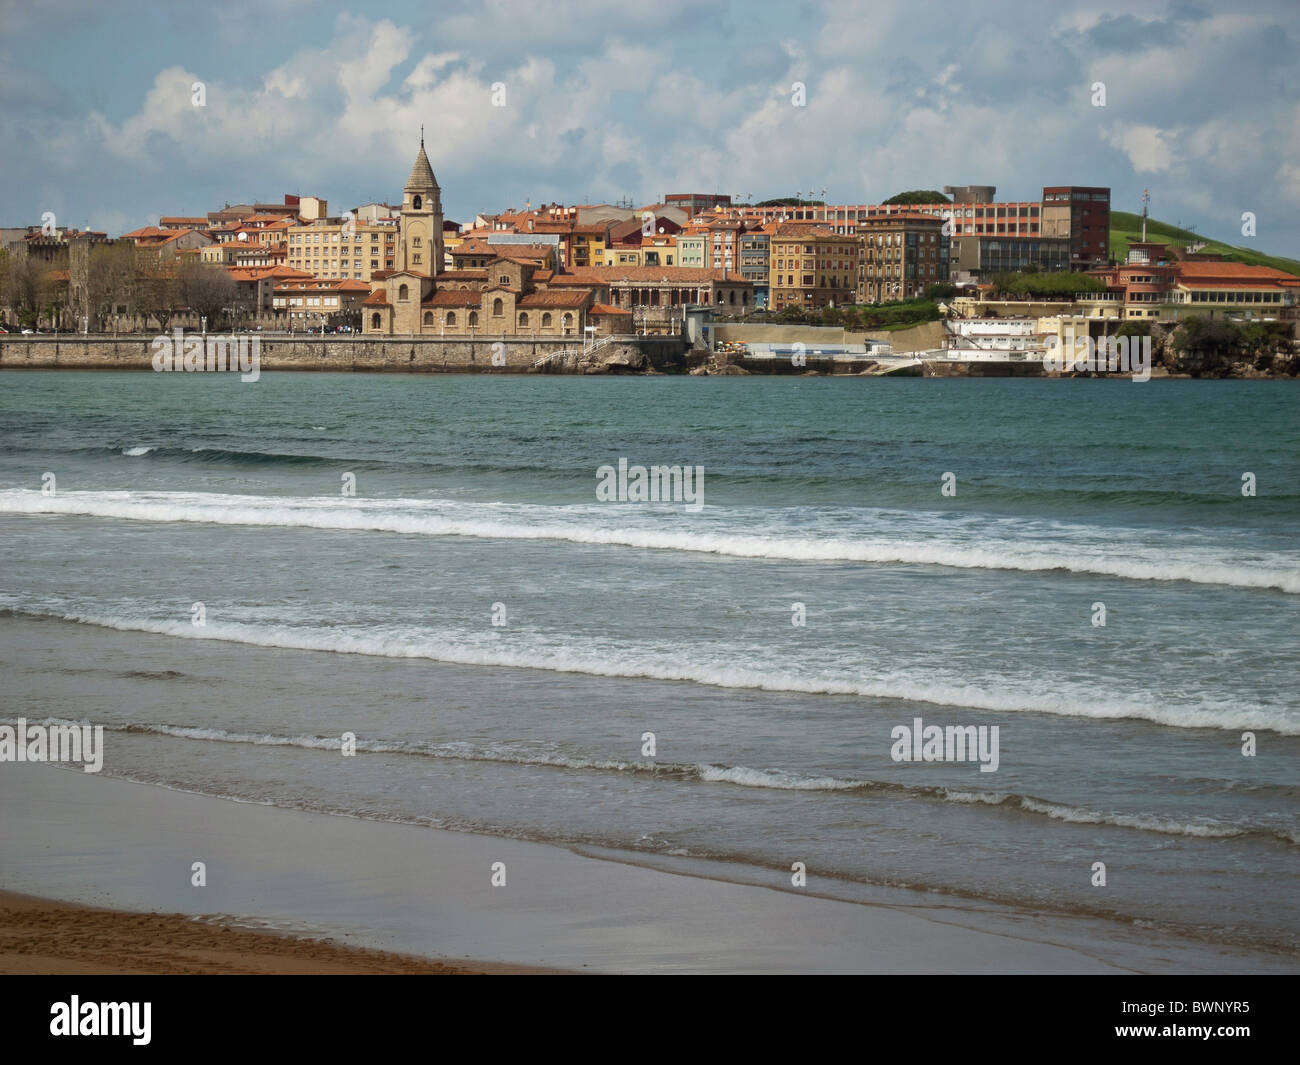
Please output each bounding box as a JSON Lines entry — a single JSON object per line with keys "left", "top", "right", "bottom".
{"left": 0, "top": 0, "right": 1300, "bottom": 257}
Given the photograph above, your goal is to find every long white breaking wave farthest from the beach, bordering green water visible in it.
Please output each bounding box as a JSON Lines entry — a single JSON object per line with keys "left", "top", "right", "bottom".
{"left": 0, "top": 489, "right": 1300, "bottom": 594}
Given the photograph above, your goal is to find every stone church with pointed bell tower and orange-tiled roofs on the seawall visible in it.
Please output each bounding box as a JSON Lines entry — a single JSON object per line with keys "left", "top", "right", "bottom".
{"left": 361, "top": 135, "right": 632, "bottom": 338}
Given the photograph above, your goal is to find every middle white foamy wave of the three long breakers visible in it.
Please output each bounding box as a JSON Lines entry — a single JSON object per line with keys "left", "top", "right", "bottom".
{"left": 0, "top": 607, "right": 1300, "bottom": 736}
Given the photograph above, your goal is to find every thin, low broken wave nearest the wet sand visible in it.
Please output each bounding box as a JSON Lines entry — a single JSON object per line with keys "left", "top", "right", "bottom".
{"left": 32, "top": 718, "right": 1300, "bottom": 845}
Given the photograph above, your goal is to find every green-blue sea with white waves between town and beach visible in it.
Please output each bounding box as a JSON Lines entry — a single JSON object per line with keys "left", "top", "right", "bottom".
{"left": 0, "top": 371, "right": 1300, "bottom": 957}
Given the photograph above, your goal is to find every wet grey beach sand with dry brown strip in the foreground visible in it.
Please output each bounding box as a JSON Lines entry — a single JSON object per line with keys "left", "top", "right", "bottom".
{"left": 0, "top": 765, "right": 1290, "bottom": 973}
